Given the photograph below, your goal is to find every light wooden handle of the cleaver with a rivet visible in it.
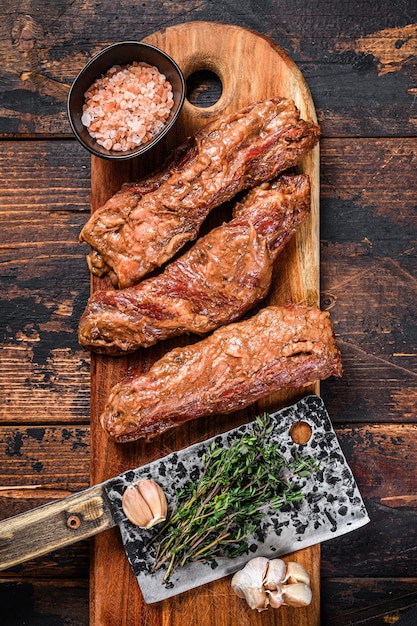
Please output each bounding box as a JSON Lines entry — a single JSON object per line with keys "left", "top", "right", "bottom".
{"left": 0, "top": 484, "right": 115, "bottom": 571}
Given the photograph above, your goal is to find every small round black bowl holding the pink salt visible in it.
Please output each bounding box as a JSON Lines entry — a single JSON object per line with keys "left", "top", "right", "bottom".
{"left": 67, "top": 41, "right": 185, "bottom": 160}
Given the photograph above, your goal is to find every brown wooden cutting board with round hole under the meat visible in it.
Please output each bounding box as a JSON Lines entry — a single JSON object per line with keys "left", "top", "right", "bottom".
{"left": 90, "top": 22, "right": 320, "bottom": 626}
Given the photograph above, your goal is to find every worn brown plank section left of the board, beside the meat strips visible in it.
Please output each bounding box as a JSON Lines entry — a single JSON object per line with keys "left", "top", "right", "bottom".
{"left": 0, "top": 141, "right": 90, "bottom": 424}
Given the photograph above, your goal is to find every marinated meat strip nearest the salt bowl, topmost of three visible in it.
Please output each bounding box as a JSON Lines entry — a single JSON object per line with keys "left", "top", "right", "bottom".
{"left": 80, "top": 98, "right": 320, "bottom": 288}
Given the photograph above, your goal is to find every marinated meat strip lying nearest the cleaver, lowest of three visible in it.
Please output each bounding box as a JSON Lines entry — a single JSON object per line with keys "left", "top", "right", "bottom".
{"left": 101, "top": 305, "right": 342, "bottom": 442}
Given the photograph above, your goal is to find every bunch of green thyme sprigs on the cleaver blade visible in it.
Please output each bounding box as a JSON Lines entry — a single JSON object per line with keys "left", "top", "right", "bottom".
{"left": 151, "top": 413, "right": 318, "bottom": 582}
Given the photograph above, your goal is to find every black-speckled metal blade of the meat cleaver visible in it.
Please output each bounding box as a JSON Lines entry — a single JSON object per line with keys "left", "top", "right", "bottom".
{"left": 104, "top": 395, "right": 369, "bottom": 604}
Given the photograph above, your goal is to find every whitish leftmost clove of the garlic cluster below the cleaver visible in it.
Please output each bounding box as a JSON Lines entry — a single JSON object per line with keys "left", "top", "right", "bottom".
{"left": 232, "top": 557, "right": 269, "bottom": 611}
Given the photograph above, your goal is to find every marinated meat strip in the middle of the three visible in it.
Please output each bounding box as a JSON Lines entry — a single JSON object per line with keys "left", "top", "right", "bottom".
{"left": 78, "top": 174, "right": 310, "bottom": 354}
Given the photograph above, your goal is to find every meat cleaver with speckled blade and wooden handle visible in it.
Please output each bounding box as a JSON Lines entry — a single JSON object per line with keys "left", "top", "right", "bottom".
{"left": 0, "top": 395, "right": 369, "bottom": 603}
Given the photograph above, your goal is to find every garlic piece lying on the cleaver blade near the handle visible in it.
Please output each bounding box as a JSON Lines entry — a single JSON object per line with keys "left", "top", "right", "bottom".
{"left": 122, "top": 479, "right": 168, "bottom": 529}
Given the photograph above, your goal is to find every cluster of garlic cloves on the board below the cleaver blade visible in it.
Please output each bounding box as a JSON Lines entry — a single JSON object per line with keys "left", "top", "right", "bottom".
{"left": 232, "top": 557, "right": 312, "bottom": 611}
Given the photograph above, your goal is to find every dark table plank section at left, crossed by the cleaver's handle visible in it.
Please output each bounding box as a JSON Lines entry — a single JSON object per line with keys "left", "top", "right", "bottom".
{"left": 0, "top": 424, "right": 90, "bottom": 579}
